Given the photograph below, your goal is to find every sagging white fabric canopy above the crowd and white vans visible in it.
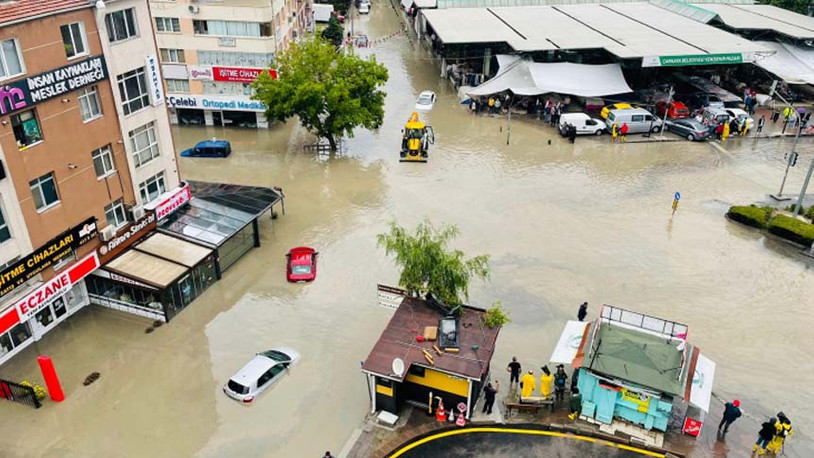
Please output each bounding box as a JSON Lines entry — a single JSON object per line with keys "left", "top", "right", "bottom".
{"left": 467, "top": 56, "right": 632, "bottom": 97}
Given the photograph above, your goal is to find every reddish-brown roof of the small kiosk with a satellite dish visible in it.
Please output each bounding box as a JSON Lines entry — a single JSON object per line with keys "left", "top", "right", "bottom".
{"left": 362, "top": 298, "right": 500, "bottom": 381}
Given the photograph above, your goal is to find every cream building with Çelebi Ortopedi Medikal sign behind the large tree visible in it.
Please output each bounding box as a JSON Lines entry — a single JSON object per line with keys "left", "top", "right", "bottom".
{"left": 150, "top": 0, "right": 311, "bottom": 127}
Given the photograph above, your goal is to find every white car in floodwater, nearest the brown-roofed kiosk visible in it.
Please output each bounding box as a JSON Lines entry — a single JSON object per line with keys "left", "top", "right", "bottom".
{"left": 223, "top": 347, "right": 300, "bottom": 403}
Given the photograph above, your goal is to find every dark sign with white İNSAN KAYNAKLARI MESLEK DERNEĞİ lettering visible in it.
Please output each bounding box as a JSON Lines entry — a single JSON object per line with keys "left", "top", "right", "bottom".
{"left": 0, "top": 56, "right": 108, "bottom": 115}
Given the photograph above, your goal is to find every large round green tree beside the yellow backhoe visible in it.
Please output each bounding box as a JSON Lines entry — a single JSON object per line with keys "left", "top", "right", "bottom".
{"left": 253, "top": 39, "right": 387, "bottom": 151}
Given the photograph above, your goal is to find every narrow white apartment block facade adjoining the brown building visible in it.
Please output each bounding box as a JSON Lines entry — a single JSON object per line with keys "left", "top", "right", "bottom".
{"left": 95, "top": 0, "right": 179, "bottom": 205}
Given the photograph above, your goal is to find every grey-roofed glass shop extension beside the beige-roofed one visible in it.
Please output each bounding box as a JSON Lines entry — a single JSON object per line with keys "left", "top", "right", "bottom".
{"left": 157, "top": 181, "right": 285, "bottom": 275}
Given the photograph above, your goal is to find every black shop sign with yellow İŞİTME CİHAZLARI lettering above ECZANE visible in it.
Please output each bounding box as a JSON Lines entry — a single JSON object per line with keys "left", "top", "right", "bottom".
{"left": 0, "top": 216, "right": 96, "bottom": 297}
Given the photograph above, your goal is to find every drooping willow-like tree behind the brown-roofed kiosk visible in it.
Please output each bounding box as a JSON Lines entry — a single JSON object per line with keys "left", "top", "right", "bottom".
{"left": 378, "top": 220, "right": 489, "bottom": 306}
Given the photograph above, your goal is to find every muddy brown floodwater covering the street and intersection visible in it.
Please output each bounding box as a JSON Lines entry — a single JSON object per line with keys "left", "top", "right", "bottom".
{"left": 0, "top": 3, "right": 814, "bottom": 457}
